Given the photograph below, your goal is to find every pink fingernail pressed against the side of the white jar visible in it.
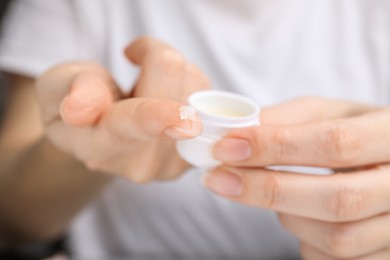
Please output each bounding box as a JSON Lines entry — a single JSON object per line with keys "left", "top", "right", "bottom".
{"left": 213, "top": 138, "right": 252, "bottom": 162}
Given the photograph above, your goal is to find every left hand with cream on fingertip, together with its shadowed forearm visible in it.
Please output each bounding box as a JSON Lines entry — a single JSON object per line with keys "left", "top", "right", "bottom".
{"left": 0, "top": 37, "right": 209, "bottom": 246}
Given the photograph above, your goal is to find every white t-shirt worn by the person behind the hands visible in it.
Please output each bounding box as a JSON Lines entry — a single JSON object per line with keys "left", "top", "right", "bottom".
{"left": 0, "top": 0, "right": 390, "bottom": 259}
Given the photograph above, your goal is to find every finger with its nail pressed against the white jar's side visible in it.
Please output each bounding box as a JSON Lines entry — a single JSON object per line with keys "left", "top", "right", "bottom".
{"left": 214, "top": 109, "right": 390, "bottom": 168}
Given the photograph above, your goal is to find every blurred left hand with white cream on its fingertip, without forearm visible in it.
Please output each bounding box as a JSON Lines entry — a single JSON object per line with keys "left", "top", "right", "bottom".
{"left": 37, "top": 37, "right": 209, "bottom": 183}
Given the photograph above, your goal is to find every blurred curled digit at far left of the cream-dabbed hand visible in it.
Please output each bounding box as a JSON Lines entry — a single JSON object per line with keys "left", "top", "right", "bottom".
{"left": 36, "top": 62, "right": 120, "bottom": 126}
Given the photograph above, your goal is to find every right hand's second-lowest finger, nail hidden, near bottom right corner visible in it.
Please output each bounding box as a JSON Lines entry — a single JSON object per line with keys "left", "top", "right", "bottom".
{"left": 279, "top": 214, "right": 390, "bottom": 258}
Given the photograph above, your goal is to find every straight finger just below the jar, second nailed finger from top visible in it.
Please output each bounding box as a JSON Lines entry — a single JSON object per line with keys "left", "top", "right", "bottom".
{"left": 203, "top": 166, "right": 390, "bottom": 222}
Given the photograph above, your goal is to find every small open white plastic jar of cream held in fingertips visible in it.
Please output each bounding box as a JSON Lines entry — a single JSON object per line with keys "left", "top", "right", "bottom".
{"left": 176, "top": 90, "right": 260, "bottom": 169}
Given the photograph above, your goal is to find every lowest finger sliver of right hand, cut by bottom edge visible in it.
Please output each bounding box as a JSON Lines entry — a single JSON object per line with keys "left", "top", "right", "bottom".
{"left": 301, "top": 243, "right": 390, "bottom": 260}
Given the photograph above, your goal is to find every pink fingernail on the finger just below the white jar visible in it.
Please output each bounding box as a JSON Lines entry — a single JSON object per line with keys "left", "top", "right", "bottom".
{"left": 201, "top": 171, "right": 243, "bottom": 197}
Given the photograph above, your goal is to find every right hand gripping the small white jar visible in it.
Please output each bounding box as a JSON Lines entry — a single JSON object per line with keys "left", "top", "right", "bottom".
{"left": 203, "top": 99, "right": 390, "bottom": 260}
